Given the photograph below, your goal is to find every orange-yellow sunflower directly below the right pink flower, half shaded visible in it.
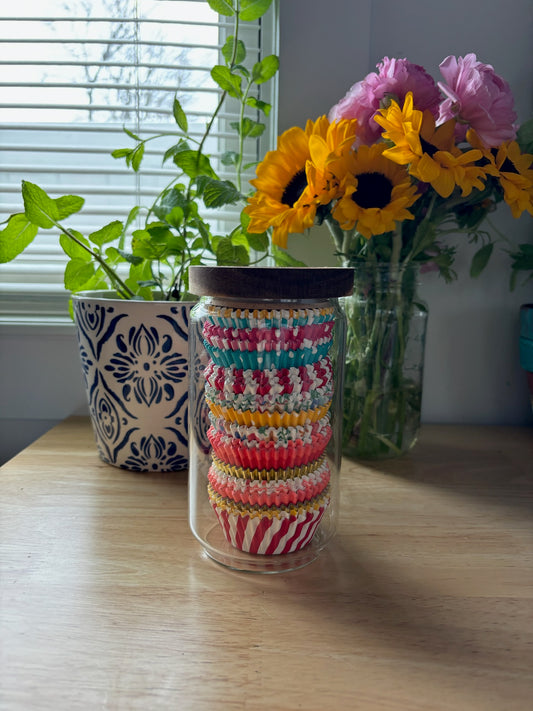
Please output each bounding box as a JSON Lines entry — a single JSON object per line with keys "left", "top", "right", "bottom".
{"left": 375, "top": 92, "right": 486, "bottom": 198}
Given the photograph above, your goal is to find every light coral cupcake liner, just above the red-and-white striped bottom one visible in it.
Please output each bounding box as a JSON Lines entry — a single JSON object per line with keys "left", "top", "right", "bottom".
{"left": 207, "top": 461, "right": 331, "bottom": 506}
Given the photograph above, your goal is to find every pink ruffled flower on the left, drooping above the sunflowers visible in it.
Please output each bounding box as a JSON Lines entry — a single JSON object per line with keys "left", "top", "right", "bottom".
{"left": 328, "top": 57, "right": 442, "bottom": 145}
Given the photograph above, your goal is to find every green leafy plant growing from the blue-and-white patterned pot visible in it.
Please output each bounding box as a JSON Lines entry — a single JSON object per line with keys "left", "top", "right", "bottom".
{"left": 0, "top": 0, "right": 279, "bottom": 300}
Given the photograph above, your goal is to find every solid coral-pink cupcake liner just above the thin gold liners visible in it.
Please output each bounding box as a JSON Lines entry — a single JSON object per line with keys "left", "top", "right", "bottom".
{"left": 207, "top": 426, "right": 331, "bottom": 469}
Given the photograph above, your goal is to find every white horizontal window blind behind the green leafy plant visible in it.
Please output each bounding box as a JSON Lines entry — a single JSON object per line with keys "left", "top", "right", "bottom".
{"left": 0, "top": 0, "right": 277, "bottom": 323}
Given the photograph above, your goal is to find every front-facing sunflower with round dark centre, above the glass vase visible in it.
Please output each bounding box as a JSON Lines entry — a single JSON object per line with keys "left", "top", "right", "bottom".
{"left": 333, "top": 143, "right": 418, "bottom": 239}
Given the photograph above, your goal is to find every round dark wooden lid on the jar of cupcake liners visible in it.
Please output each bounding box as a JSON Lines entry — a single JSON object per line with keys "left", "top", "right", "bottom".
{"left": 189, "top": 266, "right": 354, "bottom": 300}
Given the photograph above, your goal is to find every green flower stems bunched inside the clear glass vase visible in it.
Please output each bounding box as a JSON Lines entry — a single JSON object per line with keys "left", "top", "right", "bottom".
{"left": 343, "top": 231, "right": 417, "bottom": 457}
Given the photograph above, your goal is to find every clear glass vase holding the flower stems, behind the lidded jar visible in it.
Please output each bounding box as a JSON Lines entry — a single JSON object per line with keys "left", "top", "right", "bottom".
{"left": 343, "top": 263, "right": 428, "bottom": 459}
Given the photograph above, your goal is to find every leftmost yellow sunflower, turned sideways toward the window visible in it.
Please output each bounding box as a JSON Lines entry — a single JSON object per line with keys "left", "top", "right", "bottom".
{"left": 244, "top": 116, "right": 329, "bottom": 249}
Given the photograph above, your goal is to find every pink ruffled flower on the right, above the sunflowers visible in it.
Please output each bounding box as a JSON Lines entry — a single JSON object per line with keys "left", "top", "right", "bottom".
{"left": 438, "top": 54, "right": 516, "bottom": 148}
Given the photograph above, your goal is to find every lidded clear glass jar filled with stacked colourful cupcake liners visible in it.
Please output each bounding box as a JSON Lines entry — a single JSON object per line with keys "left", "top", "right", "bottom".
{"left": 189, "top": 266, "right": 353, "bottom": 573}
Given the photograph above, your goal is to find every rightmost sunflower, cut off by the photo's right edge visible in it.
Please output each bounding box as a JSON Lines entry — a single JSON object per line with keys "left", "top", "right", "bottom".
{"left": 466, "top": 129, "right": 533, "bottom": 218}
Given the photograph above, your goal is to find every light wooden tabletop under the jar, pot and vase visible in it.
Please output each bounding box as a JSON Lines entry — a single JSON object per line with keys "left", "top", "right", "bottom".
{"left": 0, "top": 418, "right": 533, "bottom": 711}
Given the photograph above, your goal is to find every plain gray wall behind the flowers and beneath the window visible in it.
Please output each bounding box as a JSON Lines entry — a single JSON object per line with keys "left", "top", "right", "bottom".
{"left": 0, "top": 0, "right": 533, "bottom": 461}
